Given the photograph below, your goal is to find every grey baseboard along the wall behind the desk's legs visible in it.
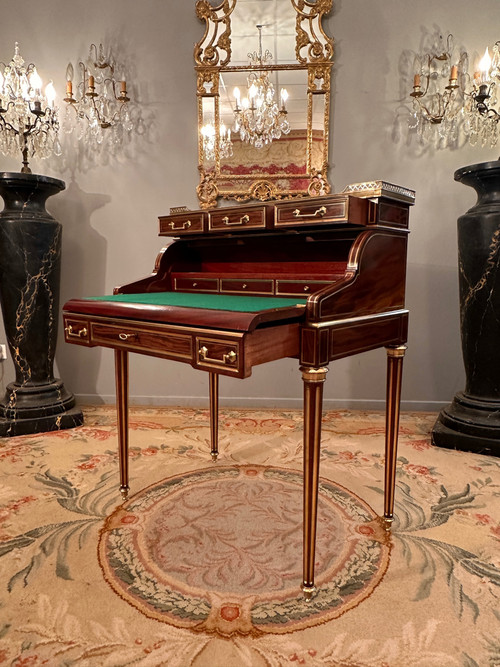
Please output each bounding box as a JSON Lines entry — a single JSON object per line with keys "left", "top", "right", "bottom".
{"left": 76, "top": 394, "right": 449, "bottom": 412}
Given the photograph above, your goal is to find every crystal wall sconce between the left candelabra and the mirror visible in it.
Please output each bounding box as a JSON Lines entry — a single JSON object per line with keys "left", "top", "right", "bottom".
{"left": 64, "top": 44, "right": 133, "bottom": 147}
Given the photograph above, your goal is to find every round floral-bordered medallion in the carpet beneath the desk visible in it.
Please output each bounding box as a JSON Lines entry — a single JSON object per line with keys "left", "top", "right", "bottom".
{"left": 99, "top": 466, "right": 390, "bottom": 636}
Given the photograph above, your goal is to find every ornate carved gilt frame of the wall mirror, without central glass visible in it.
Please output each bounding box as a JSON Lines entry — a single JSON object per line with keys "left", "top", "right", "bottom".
{"left": 194, "top": 0, "right": 333, "bottom": 209}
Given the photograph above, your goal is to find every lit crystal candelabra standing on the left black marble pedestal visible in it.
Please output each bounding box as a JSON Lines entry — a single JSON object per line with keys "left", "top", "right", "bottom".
{"left": 0, "top": 42, "right": 61, "bottom": 174}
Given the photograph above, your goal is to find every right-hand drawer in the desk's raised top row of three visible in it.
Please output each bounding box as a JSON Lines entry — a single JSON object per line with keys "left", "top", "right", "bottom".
{"left": 274, "top": 196, "right": 348, "bottom": 227}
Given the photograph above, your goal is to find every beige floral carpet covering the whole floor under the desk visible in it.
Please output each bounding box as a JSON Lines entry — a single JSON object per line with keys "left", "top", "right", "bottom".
{"left": 0, "top": 407, "right": 500, "bottom": 667}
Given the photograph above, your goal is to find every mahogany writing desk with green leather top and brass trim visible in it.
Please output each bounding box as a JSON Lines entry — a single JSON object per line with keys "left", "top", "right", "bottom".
{"left": 63, "top": 181, "right": 414, "bottom": 597}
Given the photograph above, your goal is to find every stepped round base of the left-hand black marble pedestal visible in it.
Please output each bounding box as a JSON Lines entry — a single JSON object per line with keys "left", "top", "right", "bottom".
{"left": 0, "top": 379, "right": 83, "bottom": 437}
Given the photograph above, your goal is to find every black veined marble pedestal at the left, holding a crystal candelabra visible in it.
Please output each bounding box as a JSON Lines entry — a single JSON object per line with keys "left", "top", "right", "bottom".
{"left": 0, "top": 172, "right": 83, "bottom": 436}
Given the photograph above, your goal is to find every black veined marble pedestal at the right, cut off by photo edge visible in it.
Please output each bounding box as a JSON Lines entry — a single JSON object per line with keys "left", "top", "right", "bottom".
{"left": 432, "top": 161, "right": 500, "bottom": 456}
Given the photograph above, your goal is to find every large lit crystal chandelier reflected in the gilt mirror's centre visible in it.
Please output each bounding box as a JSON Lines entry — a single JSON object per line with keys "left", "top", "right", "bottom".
{"left": 233, "top": 24, "right": 290, "bottom": 148}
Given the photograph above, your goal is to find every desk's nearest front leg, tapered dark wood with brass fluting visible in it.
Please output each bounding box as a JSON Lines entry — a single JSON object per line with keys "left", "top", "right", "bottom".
{"left": 301, "top": 367, "right": 328, "bottom": 599}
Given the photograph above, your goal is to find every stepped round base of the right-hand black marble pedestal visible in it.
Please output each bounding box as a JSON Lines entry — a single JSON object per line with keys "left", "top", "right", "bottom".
{"left": 432, "top": 392, "right": 500, "bottom": 456}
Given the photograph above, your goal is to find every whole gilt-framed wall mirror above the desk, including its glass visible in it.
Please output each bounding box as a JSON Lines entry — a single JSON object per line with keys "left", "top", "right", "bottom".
{"left": 194, "top": 0, "right": 333, "bottom": 209}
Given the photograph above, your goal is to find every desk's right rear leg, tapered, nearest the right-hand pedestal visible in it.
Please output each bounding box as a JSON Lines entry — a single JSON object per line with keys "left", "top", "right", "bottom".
{"left": 384, "top": 345, "right": 406, "bottom": 531}
